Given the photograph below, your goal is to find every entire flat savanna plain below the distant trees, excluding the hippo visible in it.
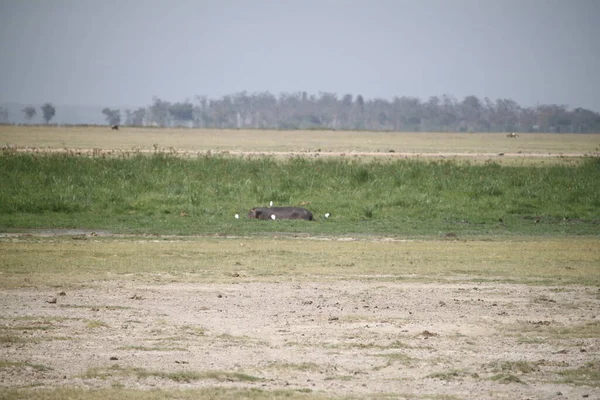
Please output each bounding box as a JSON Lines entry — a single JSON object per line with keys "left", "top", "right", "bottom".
{"left": 0, "top": 126, "right": 600, "bottom": 399}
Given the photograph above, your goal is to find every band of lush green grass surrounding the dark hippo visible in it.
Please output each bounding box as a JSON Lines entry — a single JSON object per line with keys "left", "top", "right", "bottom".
{"left": 0, "top": 152, "right": 600, "bottom": 235}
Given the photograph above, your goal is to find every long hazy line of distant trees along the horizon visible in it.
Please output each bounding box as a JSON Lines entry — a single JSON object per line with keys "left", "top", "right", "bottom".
{"left": 102, "top": 92, "right": 600, "bottom": 133}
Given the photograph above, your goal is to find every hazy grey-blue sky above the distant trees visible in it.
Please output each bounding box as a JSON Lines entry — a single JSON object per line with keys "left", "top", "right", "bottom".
{"left": 0, "top": 0, "right": 600, "bottom": 111}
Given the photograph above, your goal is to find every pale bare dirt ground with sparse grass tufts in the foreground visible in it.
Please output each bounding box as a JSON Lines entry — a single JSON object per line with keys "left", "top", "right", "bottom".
{"left": 0, "top": 276, "right": 600, "bottom": 399}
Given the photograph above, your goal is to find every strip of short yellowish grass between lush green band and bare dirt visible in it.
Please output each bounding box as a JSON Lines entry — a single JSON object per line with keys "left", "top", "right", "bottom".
{"left": 0, "top": 237, "right": 600, "bottom": 288}
